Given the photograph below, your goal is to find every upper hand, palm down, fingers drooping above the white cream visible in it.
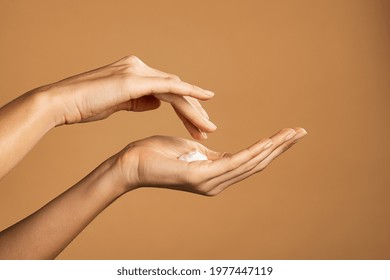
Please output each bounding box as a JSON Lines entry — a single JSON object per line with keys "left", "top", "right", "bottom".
{"left": 43, "top": 56, "right": 216, "bottom": 140}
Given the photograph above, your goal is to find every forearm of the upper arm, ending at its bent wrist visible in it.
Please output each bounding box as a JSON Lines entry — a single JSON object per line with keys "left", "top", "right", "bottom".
{"left": 0, "top": 90, "right": 61, "bottom": 178}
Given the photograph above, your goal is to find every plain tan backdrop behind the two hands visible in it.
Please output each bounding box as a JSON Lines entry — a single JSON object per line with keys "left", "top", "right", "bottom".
{"left": 0, "top": 0, "right": 390, "bottom": 259}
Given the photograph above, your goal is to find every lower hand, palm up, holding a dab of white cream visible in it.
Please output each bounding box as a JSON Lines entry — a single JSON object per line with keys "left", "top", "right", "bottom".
{"left": 116, "top": 128, "right": 306, "bottom": 196}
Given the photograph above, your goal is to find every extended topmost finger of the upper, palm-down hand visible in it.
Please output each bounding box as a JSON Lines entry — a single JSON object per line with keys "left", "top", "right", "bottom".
{"left": 127, "top": 76, "right": 214, "bottom": 100}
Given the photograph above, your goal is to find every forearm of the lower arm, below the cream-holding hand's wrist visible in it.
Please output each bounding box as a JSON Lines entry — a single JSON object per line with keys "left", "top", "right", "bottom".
{"left": 0, "top": 155, "right": 123, "bottom": 259}
